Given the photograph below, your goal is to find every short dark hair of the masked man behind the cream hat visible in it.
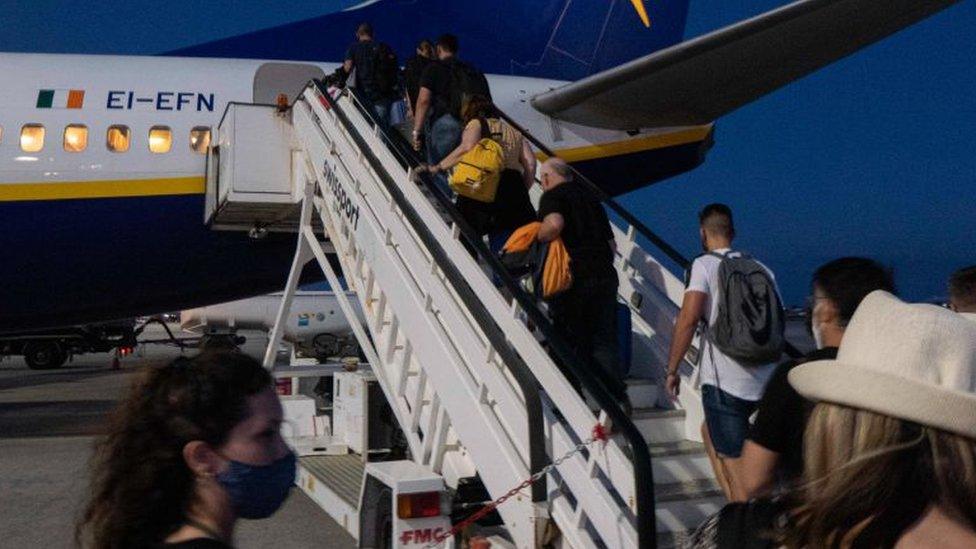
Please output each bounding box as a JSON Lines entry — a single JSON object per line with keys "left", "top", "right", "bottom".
{"left": 813, "top": 257, "right": 895, "bottom": 326}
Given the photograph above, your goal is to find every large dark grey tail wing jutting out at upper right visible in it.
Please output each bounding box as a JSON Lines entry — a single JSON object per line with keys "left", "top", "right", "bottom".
{"left": 532, "top": 0, "right": 958, "bottom": 130}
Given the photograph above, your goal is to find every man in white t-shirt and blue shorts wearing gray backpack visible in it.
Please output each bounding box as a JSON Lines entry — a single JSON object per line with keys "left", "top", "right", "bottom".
{"left": 666, "top": 204, "right": 785, "bottom": 499}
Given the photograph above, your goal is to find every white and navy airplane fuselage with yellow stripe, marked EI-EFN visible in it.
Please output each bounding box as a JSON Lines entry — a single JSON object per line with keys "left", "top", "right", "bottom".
{"left": 0, "top": 54, "right": 708, "bottom": 332}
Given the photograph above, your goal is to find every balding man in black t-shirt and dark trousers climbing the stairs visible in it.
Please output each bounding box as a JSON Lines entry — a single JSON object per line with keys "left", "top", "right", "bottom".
{"left": 538, "top": 157, "right": 629, "bottom": 408}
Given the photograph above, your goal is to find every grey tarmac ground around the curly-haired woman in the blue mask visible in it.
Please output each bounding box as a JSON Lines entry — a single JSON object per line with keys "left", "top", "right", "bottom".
{"left": 0, "top": 350, "right": 356, "bottom": 549}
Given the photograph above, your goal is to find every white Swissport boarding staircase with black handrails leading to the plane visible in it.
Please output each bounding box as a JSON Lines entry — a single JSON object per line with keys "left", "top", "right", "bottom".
{"left": 207, "top": 83, "right": 722, "bottom": 547}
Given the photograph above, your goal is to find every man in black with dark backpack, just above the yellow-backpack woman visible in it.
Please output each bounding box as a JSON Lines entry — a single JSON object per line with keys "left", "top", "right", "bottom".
{"left": 413, "top": 34, "right": 491, "bottom": 165}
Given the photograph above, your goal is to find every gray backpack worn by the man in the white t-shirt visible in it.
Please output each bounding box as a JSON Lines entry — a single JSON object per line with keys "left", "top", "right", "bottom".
{"left": 708, "top": 252, "right": 786, "bottom": 366}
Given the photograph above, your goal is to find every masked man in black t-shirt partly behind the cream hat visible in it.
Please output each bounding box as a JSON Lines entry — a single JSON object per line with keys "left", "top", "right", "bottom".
{"left": 733, "top": 257, "right": 894, "bottom": 501}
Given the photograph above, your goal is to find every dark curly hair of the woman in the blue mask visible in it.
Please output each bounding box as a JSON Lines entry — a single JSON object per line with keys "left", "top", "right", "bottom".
{"left": 75, "top": 351, "right": 272, "bottom": 549}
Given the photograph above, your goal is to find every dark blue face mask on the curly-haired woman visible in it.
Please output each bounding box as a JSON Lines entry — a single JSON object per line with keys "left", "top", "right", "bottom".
{"left": 217, "top": 451, "right": 296, "bottom": 519}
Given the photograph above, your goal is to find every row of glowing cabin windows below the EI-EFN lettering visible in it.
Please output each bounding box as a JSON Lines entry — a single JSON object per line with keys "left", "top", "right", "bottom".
{"left": 0, "top": 124, "right": 210, "bottom": 154}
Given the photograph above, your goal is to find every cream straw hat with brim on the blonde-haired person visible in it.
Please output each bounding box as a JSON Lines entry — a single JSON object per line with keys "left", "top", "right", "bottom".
{"left": 789, "top": 290, "right": 976, "bottom": 439}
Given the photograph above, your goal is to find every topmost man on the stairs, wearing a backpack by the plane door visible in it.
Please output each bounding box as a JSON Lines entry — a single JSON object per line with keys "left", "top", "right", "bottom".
{"left": 342, "top": 23, "right": 400, "bottom": 126}
